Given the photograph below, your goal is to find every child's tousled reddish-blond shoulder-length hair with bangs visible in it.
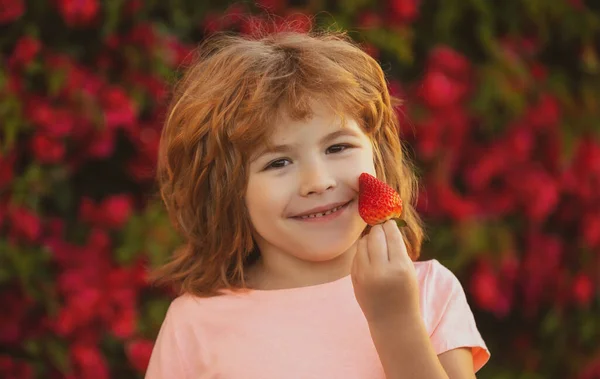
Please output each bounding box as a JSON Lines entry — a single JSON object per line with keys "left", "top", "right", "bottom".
{"left": 153, "top": 32, "right": 423, "bottom": 296}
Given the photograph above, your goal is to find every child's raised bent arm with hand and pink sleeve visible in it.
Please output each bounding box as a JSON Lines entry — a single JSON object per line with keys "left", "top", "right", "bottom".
{"left": 352, "top": 221, "right": 489, "bottom": 379}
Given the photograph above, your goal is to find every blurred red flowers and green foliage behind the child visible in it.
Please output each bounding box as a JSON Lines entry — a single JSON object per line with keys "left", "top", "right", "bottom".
{"left": 0, "top": 0, "right": 600, "bottom": 379}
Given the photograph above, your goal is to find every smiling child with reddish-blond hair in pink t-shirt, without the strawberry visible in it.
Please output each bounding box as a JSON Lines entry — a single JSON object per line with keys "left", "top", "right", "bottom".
{"left": 146, "top": 33, "right": 489, "bottom": 379}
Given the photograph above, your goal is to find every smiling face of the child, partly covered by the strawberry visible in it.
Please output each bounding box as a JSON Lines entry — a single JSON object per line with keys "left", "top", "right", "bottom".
{"left": 245, "top": 104, "right": 375, "bottom": 269}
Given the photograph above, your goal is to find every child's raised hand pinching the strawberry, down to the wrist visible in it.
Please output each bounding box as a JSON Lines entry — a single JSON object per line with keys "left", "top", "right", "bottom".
{"left": 351, "top": 220, "right": 420, "bottom": 323}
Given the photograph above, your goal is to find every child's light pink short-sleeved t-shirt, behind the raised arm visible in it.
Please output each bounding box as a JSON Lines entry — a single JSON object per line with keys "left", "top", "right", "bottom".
{"left": 146, "top": 260, "right": 490, "bottom": 379}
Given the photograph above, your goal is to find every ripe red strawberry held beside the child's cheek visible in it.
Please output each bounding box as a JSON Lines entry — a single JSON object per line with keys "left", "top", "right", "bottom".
{"left": 358, "top": 173, "right": 402, "bottom": 225}
